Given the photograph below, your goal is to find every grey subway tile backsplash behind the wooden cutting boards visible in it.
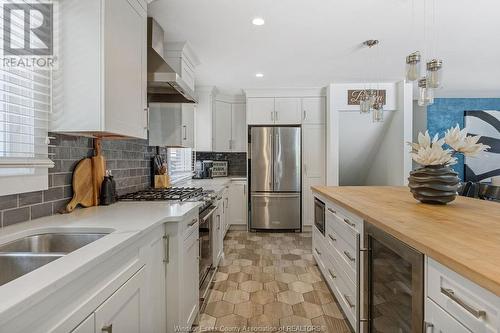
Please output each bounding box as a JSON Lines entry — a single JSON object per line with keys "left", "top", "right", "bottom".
{"left": 0, "top": 133, "right": 161, "bottom": 226}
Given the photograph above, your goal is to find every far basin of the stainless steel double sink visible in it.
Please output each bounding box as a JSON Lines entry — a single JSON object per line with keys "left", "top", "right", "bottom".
{"left": 0, "top": 233, "right": 107, "bottom": 254}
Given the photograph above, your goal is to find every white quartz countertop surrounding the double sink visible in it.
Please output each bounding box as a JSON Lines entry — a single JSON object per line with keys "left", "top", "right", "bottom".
{"left": 0, "top": 202, "right": 200, "bottom": 323}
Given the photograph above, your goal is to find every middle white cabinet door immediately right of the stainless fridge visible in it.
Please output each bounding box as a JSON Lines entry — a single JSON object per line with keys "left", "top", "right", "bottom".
{"left": 302, "top": 125, "right": 326, "bottom": 178}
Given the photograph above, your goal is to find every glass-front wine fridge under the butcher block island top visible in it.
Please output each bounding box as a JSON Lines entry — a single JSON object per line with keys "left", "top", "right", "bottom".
{"left": 359, "top": 223, "right": 424, "bottom": 333}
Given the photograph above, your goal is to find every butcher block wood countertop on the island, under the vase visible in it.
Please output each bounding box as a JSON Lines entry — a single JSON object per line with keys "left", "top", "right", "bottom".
{"left": 312, "top": 186, "right": 500, "bottom": 296}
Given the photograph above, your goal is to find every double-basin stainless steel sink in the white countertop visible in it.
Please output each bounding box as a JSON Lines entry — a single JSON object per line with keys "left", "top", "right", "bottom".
{"left": 0, "top": 233, "right": 108, "bottom": 286}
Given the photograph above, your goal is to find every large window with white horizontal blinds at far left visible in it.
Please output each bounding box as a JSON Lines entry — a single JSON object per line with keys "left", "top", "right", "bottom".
{"left": 0, "top": 1, "right": 53, "bottom": 195}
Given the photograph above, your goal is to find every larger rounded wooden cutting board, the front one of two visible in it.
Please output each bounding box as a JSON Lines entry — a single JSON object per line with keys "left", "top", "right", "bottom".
{"left": 66, "top": 158, "right": 94, "bottom": 213}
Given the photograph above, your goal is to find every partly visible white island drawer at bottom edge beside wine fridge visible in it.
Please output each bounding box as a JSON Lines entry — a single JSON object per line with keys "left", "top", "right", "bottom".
{"left": 424, "top": 298, "right": 471, "bottom": 333}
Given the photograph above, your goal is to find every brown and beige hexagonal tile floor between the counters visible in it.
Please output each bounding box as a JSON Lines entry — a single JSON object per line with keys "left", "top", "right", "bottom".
{"left": 198, "top": 231, "right": 351, "bottom": 333}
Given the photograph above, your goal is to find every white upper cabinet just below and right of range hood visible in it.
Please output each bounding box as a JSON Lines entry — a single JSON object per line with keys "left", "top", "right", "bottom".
{"left": 149, "top": 103, "right": 195, "bottom": 148}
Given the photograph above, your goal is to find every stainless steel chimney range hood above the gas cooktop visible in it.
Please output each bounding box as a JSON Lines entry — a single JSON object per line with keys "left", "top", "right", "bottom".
{"left": 148, "top": 17, "right": 197, "bottom": 103}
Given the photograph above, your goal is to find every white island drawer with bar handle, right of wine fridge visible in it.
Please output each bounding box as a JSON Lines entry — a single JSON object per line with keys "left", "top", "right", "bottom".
{"left": 427, "top": 258, "right": 500, "bottom": 332}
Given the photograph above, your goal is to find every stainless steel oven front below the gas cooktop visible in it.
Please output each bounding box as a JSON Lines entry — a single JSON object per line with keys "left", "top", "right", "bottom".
{"left": 199, "top": 205, "right": 217, "bottom": 309}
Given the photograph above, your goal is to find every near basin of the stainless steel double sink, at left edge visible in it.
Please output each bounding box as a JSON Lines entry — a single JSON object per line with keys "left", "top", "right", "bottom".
{"left": 0, "top": 253, "right": 63, "bottom": 286}
